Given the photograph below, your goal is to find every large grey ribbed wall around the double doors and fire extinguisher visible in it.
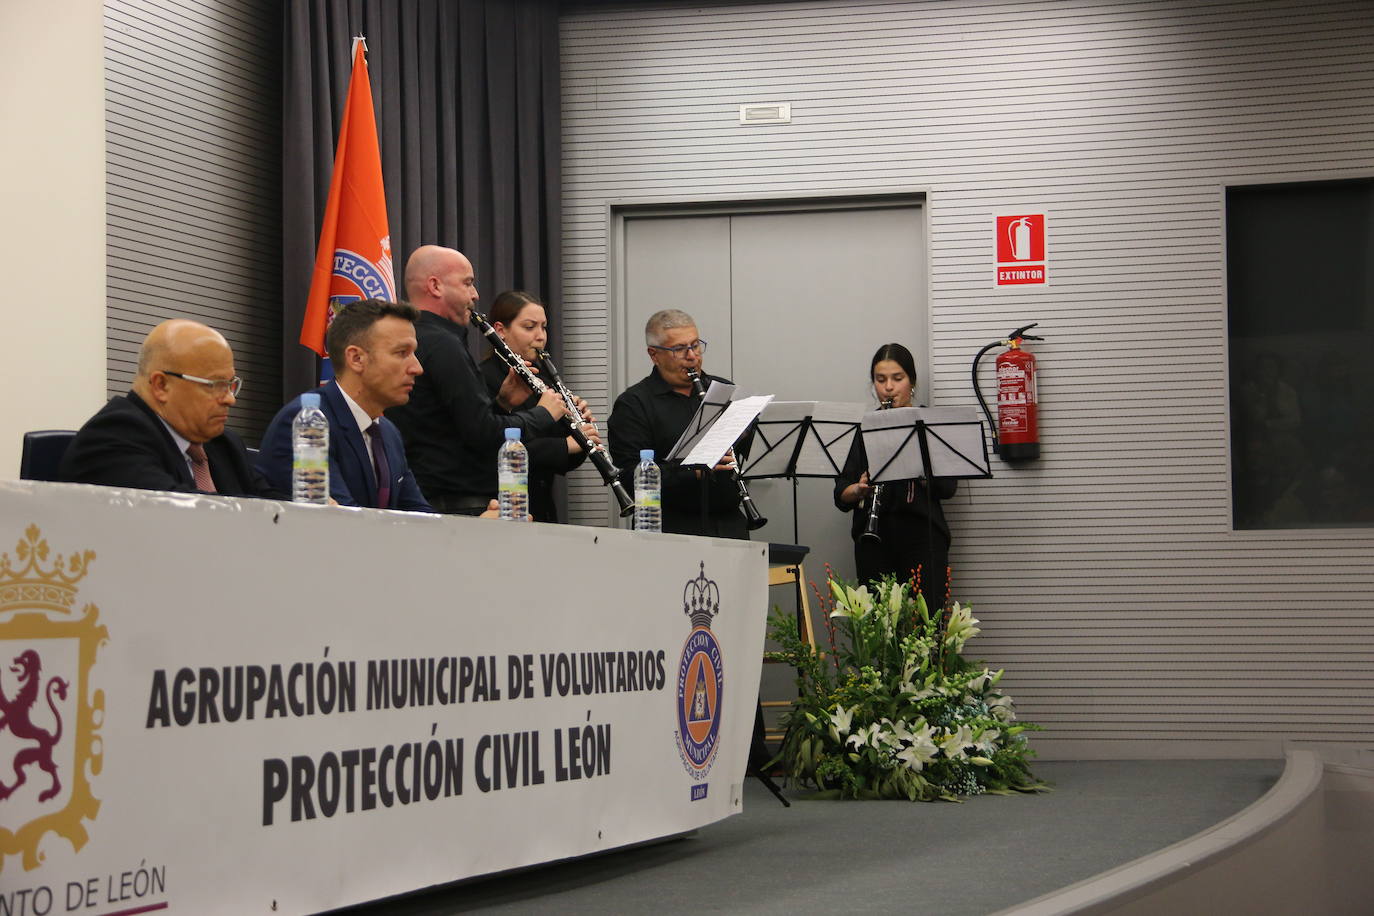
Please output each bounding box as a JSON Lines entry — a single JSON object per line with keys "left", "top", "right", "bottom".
{"left": 562, "top": 0, "right": 1374, "bottom": 757}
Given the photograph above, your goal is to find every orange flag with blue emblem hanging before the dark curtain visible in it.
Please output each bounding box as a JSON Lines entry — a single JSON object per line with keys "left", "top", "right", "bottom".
{"left": 301, "top": 40, "right": 396, "bottom": 356}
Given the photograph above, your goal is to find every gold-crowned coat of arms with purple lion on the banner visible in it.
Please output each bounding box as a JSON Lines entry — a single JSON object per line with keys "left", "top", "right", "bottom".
{"left": 0, "top": 525, "right": 109, "bottom": 872}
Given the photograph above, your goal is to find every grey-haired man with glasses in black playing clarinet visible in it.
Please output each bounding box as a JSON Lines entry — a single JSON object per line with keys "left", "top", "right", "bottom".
{"left": 606, "top": 309, "right": 749, "bottom": 540}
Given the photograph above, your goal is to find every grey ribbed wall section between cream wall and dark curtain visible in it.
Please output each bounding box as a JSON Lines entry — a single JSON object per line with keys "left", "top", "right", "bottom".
{"left": 104, "top": 0, "right": 282, "bottom": 442}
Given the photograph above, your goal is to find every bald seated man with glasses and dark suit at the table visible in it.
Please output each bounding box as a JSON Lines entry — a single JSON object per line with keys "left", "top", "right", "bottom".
{"left": 59, "top": 319, "right": 268, "bottom": 496}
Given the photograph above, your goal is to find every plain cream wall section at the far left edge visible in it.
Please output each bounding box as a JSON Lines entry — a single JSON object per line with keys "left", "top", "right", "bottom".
{"left": 0, "top": 0, "right": 104, "bottom": 478}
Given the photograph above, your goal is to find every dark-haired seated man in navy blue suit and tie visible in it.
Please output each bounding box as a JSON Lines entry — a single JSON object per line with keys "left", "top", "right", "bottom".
{"left": 257, "top": 299, "right": 431, "bottom": 512}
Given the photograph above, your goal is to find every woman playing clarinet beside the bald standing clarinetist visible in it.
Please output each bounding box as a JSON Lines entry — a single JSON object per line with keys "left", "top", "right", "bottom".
{"left": 482, "top": 290, "right": 600, "bottom": 522}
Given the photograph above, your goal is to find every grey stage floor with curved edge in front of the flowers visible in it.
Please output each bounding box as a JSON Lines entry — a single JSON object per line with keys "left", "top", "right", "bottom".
{"left": 342, "top": 759, "right": 1283, "bottom": 916}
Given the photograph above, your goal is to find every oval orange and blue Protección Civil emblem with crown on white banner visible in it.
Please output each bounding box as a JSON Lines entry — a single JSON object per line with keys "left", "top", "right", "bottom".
{"left": 677, "top": 562, "right": 725, "bottom": 798}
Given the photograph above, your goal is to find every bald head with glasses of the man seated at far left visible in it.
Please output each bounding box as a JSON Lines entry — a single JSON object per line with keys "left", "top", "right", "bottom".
{"left": 133, "top": 319, "right": 235, "bottom": 442}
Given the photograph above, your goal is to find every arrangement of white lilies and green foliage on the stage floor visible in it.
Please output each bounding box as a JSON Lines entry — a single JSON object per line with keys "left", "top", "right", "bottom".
{"left": 768, "top": 577, "right": 1044, "bottom": 801}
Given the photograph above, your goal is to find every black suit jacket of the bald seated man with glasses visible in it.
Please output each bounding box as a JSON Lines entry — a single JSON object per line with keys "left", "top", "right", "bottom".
{"left": 58, "top": 391, "right": 268, "bottom": 496}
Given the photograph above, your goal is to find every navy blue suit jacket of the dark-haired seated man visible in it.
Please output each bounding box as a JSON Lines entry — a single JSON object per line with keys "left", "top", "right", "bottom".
{"left": 257, "top": 382, "right": 433, "bottom": 512}
